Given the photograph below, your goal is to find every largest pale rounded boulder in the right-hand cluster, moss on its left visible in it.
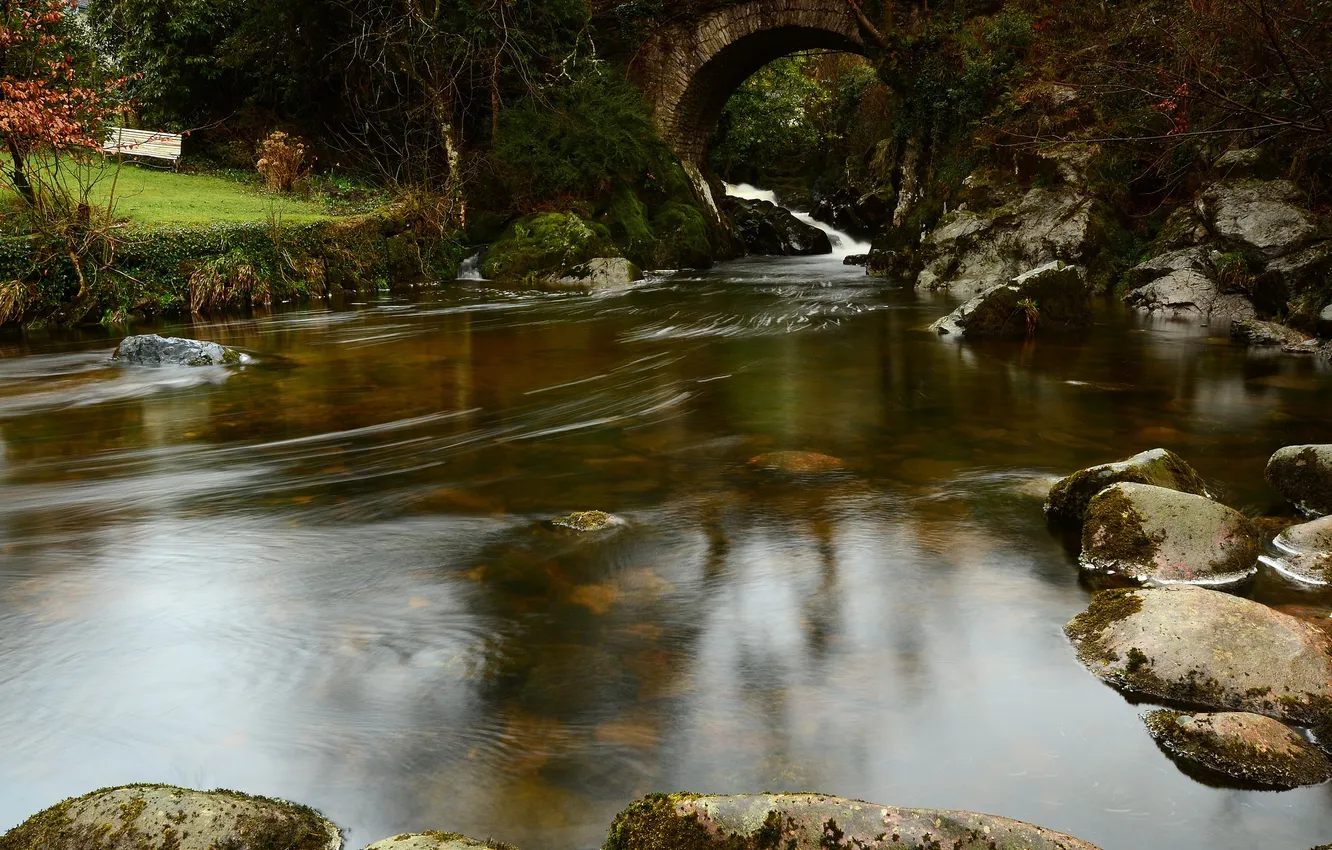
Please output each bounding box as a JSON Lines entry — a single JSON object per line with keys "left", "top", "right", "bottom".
{"left": 1064, "top": 585, "right": 1332, "bottom": 726}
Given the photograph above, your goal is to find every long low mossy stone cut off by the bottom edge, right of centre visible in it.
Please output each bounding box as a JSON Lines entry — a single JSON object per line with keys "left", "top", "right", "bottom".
{"left": 603, "top": 794, "right": 1096, "bottom": 850}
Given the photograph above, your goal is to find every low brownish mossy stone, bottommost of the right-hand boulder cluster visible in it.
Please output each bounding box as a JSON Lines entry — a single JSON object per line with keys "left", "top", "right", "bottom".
{"left": 1143, "top": 709, "right": 1332, "bottom": 789}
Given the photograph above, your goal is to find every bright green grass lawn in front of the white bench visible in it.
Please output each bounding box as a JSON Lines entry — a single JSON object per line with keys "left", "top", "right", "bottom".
{"left": 5, "top": 163, "right": 336, "bottom": 228}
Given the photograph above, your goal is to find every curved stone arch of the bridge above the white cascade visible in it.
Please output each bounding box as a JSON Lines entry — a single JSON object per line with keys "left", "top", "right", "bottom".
{"left": 631, "top": 0, "right": 867, "bottom": 167}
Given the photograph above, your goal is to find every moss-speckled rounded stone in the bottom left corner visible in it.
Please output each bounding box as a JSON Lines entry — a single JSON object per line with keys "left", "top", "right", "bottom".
{"left": 0, "top": 785, "right": 342, "bottom": 850}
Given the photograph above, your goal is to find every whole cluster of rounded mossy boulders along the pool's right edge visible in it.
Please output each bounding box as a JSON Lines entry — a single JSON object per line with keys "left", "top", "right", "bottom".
{"left": 1046, "top": 446, "right": 1332, "bottom": 789}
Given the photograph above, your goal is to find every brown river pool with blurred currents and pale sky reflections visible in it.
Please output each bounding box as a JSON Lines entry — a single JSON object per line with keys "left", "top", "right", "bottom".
{"left": 0, "top": 254, "right": 1332, "bottom": 850}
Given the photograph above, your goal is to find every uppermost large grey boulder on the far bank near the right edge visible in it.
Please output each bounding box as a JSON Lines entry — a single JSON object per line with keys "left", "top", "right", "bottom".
{"left": 1197, "top": 177, "right": 1319, "bottom": 260}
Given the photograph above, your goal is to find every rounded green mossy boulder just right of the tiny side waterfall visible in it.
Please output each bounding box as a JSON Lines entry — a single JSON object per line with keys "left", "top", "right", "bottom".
{"left": 481, "top": 213, "right": 619, "bottom": 282}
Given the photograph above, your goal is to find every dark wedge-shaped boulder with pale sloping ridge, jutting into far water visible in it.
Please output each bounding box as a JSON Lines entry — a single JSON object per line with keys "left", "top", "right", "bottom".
{"left": 930, "top": 260, "right": 1091, "bottom": 337}
